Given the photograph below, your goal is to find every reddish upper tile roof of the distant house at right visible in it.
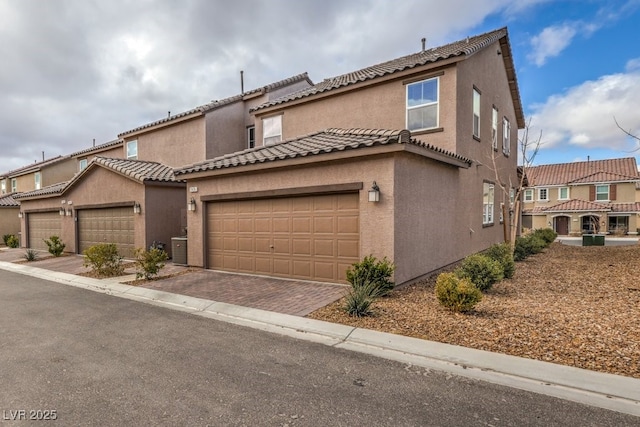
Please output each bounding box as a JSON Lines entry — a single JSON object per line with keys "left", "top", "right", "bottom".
{"left": 526, "top": 157, "right": 640, "bottom": 187}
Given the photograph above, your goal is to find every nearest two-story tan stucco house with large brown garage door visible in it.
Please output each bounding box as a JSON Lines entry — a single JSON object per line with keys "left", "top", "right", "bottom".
{"left": 176, "top": 29, "right": 524, "bottom": 284}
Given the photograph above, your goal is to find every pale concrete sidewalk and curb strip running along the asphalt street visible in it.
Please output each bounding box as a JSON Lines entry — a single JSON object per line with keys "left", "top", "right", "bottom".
{"left": 0, "top": 261, "right": 640, "bottom": 417}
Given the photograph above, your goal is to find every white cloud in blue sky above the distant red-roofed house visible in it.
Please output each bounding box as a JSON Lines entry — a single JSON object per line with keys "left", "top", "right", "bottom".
{"left": 530, "top": 70, "right": 640, "bottom": 154}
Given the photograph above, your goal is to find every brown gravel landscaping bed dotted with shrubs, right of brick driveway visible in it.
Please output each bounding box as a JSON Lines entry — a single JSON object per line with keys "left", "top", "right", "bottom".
{"left": 308, "top": 243, "right": 640, "bottom": 378}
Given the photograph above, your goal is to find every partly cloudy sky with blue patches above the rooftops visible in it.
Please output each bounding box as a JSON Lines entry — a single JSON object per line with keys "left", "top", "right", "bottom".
{"left": 0, "top": 0, "right": 640, "bottom": 173}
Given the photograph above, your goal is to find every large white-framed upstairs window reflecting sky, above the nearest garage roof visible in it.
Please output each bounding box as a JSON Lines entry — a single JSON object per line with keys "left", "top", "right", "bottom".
{"left": 407, "top": 77, "right": 440, "bottom": 130}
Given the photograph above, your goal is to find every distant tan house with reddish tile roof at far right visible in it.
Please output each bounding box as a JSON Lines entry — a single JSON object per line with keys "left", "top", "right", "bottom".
{"left": 522, "top": 157, "right": 640, "bottom": 235}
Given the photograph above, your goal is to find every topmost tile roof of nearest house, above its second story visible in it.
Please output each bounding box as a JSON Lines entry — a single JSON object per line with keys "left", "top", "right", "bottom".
{"left": 250, "top": 27, "right": 524, "bottom": 128}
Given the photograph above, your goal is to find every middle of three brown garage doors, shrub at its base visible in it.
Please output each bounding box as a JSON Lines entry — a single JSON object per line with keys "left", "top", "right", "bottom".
{"left": 78, "top": 206, "right": 134, "bottom": 258}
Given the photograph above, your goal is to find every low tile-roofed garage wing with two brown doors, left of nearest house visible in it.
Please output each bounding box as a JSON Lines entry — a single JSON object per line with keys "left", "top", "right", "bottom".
{"left": 16, "top": 157, "right": 186, "bottom": 258}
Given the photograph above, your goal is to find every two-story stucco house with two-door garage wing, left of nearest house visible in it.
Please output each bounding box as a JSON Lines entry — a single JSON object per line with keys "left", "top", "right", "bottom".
{"left": 19, "top": 73, "right": 311, "bottom": 257}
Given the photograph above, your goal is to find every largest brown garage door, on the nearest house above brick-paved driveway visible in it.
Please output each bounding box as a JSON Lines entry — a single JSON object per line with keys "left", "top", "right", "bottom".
{"left": 207, "top": 194, "right": 360, "bottom": 282}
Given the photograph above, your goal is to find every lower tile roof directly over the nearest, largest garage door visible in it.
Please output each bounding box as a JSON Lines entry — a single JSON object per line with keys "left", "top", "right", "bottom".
{"left": 175, "top": 129, "right": 471, "bottom": 175}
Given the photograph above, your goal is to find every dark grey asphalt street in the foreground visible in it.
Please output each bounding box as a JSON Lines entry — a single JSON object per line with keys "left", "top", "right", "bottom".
{"left": 0, "top": 271, "right": 640, "bottom": 426}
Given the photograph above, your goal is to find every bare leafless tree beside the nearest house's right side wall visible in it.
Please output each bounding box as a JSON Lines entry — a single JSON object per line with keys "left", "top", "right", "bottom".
{"left": 491, "top": 120, "right": 542, "bottom": 251}
